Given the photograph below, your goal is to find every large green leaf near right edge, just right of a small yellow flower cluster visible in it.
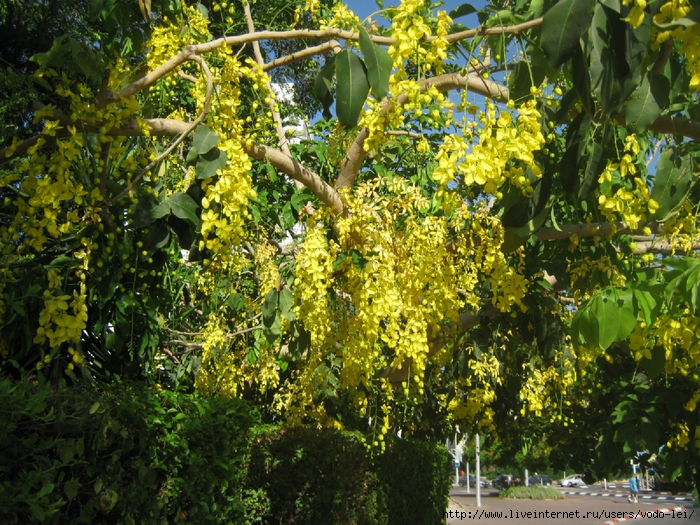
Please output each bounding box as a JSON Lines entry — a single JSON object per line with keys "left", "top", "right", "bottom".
{"left": 651, "top": 148, "right": 693, "bottom": 222}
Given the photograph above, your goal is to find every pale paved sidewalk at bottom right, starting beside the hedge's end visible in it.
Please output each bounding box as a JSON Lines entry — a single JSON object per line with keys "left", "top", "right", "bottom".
{"left": 446, "top": 489, "right": 700, "bottom": 525}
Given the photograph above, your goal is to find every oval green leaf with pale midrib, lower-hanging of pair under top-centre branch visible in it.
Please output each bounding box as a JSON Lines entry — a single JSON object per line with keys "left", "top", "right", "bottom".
{"left": 335, "top": 49, "right": 369, "bottom": 128}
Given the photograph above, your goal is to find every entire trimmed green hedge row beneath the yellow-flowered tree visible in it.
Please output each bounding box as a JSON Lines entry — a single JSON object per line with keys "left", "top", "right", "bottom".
{"left": 0, "top": 376, "right": 450, "bottom": 525}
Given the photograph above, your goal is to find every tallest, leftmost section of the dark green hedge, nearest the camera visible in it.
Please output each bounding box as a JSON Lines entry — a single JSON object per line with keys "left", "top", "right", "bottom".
{"left": 0, "top": 378, "right": 266, "bottom": 525}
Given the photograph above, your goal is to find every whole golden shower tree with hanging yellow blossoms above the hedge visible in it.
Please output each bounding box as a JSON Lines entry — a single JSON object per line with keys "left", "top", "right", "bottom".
{"left": 0, "top": 0, "right": 700, "bottom": 484}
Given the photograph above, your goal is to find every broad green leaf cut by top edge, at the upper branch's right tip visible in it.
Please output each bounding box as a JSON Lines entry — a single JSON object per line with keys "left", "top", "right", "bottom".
{"left": 541, "top": 0, "right": 595, "bottom": 68}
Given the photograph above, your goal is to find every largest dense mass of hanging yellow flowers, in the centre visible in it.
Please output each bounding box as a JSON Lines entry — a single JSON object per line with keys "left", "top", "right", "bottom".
{"left": 280, "top": 177, "right": 527, "bottom": 426}
